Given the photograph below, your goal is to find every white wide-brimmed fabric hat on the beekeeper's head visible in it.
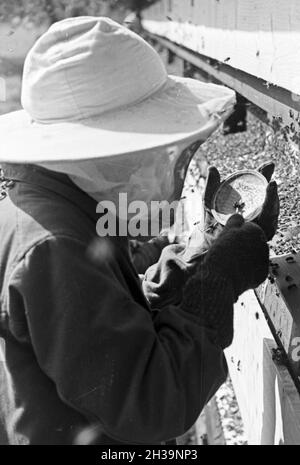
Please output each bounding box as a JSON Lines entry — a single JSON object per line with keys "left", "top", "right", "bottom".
{"left": 0, "top": 17, "right": 235, "bottom": 165}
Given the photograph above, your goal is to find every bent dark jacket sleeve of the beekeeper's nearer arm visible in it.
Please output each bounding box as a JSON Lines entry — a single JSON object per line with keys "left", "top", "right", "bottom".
{"left": 10, "top": 237, "right": 227, "bottom": 444}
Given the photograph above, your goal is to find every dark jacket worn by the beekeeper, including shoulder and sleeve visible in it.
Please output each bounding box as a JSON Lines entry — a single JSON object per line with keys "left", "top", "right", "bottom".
{"left": 0, "top": 165, "right": 227, "bottom": 444}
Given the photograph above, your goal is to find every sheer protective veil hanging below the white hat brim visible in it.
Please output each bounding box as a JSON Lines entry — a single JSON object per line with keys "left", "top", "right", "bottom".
{"left": 43, "top": 142, "right": 200, "bottom": 239}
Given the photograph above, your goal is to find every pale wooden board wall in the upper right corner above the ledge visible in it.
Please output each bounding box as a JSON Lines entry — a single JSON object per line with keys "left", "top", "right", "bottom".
{"left": 144, "top": 0, "right": 300, "bottom": 96}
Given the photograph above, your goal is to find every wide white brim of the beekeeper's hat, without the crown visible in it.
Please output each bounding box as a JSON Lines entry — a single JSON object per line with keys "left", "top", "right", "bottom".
{"left": 0, "top": 76, "right": 235, "bottom": 165}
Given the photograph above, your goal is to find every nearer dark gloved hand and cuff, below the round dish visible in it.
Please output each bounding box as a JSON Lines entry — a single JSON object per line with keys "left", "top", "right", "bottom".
{"left": 182, "top": 214, "right": 269, "bottom": 348}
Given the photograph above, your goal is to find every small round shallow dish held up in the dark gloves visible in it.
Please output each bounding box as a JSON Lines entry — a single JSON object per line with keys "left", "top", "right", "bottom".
{"left": 212, "top": 170, "right": 268, "bottom": 225}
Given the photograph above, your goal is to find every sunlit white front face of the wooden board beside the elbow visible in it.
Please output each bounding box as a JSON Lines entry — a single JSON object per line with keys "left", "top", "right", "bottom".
{"left": 225, "top": 291, "right": 273, "bottom": 444}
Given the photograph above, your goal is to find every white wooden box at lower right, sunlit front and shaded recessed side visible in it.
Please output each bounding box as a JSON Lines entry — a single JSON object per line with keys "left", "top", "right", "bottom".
{"left": 226, "top": 291, "right": 300, "bottom": 445}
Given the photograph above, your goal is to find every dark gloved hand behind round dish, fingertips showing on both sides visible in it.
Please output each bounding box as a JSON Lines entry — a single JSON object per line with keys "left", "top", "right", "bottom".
{"left": 204, "top": 162, "right": 279, "bottom": 241}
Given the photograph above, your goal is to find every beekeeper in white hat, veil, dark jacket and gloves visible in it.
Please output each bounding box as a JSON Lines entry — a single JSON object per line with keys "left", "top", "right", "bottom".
{"left": 0, "top": 17, "right": 276, "bottom": 444}
